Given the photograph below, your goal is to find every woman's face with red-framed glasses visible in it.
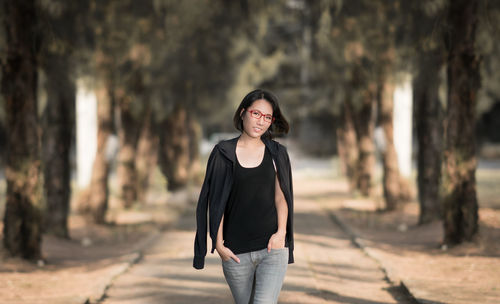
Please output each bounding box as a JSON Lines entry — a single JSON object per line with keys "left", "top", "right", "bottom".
{"left": 240, "top": 99, "right": 273, "bottom": 138}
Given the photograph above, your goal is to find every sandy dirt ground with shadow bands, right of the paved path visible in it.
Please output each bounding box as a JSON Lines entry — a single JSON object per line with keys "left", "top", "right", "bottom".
{"left": 308, "top": 176, "right": 500, "bottom": 304}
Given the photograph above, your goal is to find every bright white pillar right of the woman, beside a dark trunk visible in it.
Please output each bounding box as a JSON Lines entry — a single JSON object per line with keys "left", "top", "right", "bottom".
{"left": 394, "top": 75, "right": 413, "bottom": 178}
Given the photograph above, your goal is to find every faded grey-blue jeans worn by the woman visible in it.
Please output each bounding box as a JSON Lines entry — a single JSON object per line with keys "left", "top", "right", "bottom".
{"left": 222, "top": 248, "right": 288, "bottom": 304}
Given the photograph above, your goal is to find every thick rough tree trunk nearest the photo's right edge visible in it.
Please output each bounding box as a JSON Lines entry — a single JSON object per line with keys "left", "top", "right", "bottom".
{"left": 443, "top": 0, "right": 480, "bottom": 244}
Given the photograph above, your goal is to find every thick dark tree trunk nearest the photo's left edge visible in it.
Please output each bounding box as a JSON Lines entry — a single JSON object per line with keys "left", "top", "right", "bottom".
{"left": 1, "top": 0, "right": 43, "bottom": 259}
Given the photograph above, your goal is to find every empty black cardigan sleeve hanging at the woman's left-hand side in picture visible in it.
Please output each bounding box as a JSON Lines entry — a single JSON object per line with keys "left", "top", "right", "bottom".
{"left": 193, "top": 147, "right": 217, "bottom": 269}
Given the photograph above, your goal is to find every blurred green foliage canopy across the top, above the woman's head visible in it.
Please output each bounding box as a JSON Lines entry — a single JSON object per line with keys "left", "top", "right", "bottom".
{"left": 0, "top": 0, "right": 500, "bottom": 138}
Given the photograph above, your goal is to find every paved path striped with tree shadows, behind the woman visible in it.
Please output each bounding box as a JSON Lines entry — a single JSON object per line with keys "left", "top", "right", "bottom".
{"left": 103, "top": 179, "right": 412, "bottom": 304}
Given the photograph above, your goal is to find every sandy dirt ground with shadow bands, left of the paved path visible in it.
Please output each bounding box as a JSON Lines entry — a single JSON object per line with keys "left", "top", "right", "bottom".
{"left": 0, "top": 182, "right": 197, "bottom": 304}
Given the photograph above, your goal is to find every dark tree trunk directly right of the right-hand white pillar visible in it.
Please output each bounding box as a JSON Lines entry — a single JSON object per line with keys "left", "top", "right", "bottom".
{"left": 410, "top": 0, "right": 447, "bottom": 224}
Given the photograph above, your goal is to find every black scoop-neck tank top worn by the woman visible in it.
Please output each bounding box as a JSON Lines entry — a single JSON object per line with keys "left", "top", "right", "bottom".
{"left": 223, "top": 149, "right": 278, "bottom": 254}
